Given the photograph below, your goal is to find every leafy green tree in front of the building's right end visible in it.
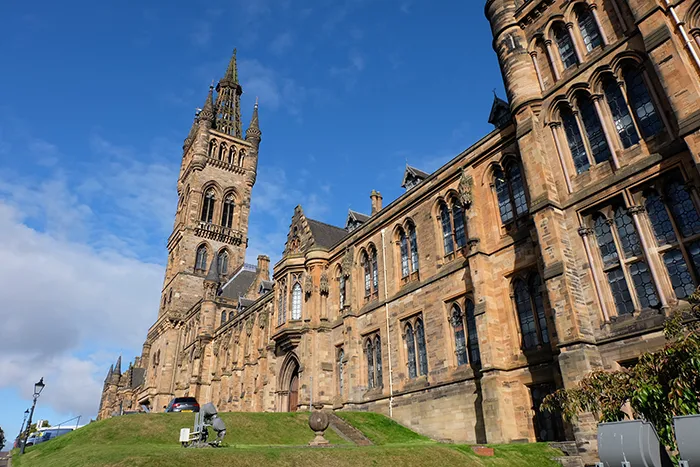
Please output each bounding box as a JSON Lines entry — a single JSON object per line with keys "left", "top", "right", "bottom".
{"left": 542, "top": 288, "right": 700, "bottom": 450}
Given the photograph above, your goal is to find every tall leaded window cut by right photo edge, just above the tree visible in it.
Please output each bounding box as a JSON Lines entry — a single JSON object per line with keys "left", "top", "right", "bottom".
{"left": 644, "top": 179, "right": 700, "bottom": 299}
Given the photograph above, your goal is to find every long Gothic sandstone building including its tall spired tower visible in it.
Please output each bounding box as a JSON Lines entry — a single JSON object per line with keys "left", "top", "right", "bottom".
{"left": 99, "top": 0, "right": 700, "bottom": 460}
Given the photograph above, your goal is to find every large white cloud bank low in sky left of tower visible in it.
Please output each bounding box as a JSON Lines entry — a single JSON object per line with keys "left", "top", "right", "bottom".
{"left": 0, "top": 201, "right": 163, "bottom": 415}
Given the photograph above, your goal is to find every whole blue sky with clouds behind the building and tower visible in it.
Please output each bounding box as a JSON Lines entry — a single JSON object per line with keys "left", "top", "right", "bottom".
{"left": 0, "top": 0, "right": 504, "bottom": 446}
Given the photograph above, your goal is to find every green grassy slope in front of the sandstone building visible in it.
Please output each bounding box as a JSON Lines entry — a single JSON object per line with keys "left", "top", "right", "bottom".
{"left": 13, "top": 412, "right": 557, "bottom": 467}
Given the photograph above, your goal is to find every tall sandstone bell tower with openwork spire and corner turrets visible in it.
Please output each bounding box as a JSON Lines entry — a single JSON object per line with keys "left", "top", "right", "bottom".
{"left": 159, "top": 49, "right": 262, "bottom": 324}
